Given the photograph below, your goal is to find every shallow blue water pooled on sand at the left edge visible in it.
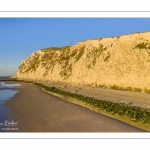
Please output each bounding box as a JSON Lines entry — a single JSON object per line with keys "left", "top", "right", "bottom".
{"left": 0, "top": 82, "right": 19, "bottom": 129}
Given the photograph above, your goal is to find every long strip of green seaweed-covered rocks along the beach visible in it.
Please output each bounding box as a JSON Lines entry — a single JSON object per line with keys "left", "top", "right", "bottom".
{"left": 36, "top": 83, "right": 150, "bottom": 124}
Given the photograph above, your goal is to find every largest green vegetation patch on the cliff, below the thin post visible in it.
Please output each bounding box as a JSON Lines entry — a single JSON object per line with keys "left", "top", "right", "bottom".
{"left": 41, "top": 46, "right": 84, "bottom": 79}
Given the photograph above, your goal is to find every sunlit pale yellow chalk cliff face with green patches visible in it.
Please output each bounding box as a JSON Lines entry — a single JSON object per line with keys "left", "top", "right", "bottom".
{"left": 16, "top": 32, "right": 150, "bottom": 89}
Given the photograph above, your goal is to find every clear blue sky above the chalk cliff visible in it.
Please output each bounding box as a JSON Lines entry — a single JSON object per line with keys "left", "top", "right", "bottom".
{"left": 0, "top": 18, "right": 150, "bottom": 76}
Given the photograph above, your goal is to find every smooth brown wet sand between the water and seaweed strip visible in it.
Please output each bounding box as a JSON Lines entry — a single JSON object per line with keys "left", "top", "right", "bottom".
{"left": 5, "top": 83, "right": 145, "bottom": 132}
